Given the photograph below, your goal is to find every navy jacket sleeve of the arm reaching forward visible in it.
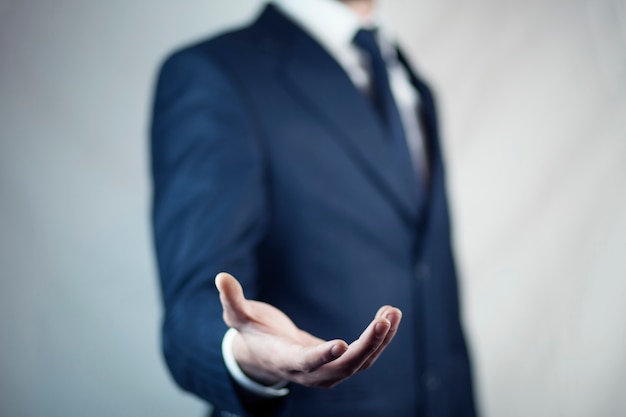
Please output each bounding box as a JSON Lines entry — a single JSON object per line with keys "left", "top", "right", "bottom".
{"left": 151, "top": 47, "right": 267, "bottom": 414}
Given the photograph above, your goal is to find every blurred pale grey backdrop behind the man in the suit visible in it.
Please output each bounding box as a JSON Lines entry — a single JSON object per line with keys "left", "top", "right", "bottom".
{"left": 0, "top": 0, "right": 626, "bottom": 417}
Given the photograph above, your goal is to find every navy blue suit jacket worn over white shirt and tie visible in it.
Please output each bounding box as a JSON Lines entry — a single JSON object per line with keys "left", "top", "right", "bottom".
{"left": 152, "top": 5, "right": 475, "bottom": 417}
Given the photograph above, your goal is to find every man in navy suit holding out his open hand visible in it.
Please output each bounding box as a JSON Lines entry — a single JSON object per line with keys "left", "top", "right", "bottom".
{"left": 152, "top": 0, "right": 475, "bottom": 417}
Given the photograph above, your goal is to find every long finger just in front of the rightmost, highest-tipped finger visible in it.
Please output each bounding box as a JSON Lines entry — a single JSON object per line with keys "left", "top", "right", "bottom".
{"left": 327, "top": 317, "right": 391, "bottom": 379}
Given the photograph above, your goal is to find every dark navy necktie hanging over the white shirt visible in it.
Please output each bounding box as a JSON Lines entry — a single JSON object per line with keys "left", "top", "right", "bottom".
{"left": 354, "top": 29, "right": 420, "bottom": 202}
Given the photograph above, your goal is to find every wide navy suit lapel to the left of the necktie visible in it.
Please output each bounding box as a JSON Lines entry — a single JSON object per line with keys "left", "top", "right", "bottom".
{"left": 260, "top": 6, "right": 416, "bottom": 222}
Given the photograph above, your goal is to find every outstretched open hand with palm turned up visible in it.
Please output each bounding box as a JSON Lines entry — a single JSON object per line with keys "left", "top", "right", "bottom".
{"left": 215, "top": 272, "right": 402, "bottom": 388}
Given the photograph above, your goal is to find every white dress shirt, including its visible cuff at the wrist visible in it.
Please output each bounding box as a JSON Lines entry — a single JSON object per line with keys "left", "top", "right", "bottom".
{"left": 222, "top": 0, "right": 428, "bottom": 397}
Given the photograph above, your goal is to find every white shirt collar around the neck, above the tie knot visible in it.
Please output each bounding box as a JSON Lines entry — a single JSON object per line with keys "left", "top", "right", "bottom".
{"left": 273, "top": 0, "right": 393, "bottom": 51}
